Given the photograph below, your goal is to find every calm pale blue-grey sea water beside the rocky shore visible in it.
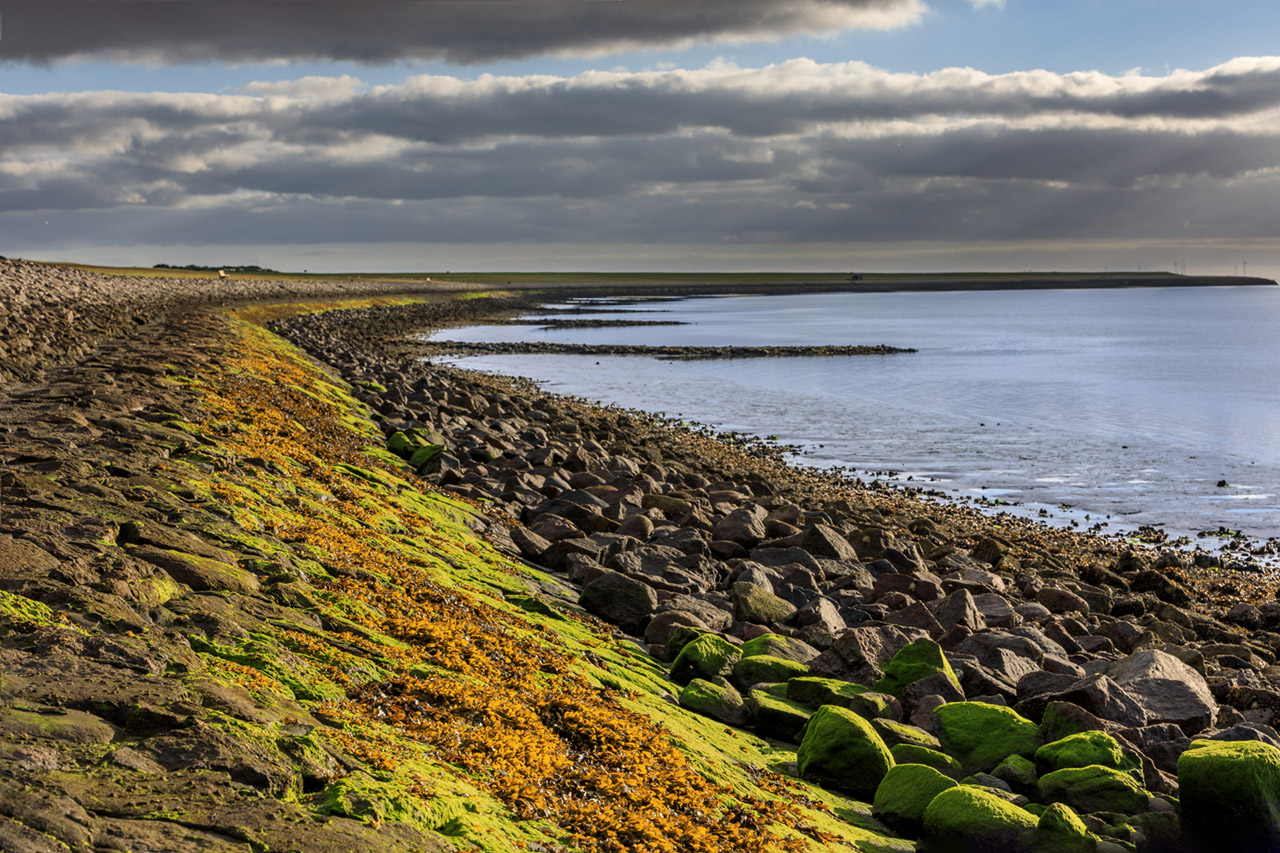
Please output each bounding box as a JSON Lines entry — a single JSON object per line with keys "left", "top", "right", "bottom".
{"left": 430, "top": 287, "right": 1280, "bottom": 538}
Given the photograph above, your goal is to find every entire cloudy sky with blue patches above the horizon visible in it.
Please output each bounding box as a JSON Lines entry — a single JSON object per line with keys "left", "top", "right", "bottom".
{"left": 0, "top": 0, "right": 1280, "bottom": 277}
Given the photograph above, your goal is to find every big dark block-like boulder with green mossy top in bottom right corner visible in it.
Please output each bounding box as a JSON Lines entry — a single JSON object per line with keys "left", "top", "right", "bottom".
{"left": 1178, "top": 740, "right": 1280, "bottom": 853}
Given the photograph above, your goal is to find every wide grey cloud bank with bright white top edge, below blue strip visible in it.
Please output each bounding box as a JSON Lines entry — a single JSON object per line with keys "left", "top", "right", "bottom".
{"left": 0, "top": 58, "right": 1280, "bottom": 254}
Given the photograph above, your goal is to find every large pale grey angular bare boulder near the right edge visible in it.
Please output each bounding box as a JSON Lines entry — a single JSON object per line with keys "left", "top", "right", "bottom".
{"left": 1107, "top": 648, "right": 1217, "bottom": 734}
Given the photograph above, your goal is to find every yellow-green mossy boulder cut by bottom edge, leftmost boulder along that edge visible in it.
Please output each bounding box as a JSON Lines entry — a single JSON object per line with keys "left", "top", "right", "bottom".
{"left": 920, "top": 785, "right": 1038, "bottom": 853}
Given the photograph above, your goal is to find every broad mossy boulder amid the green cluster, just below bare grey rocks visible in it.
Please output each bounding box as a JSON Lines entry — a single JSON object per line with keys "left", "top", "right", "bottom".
{"left": 933, "top": 702, "right": 1041, "bottom": 772}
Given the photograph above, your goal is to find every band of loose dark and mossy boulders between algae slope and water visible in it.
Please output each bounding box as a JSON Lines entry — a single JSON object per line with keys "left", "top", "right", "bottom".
{"left": 283, "top": 298, "right": 1280, "bottom": 853}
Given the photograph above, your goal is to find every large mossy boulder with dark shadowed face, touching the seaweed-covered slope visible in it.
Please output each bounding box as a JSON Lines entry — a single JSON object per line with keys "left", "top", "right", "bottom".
{"left": 796, "top": 704, "right": 893, "bottom": 799}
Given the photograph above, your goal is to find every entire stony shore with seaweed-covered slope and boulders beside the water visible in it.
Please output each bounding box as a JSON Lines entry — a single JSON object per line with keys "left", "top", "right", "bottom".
{"left": 0, "top": 265, "right": 1280, "bottom": 852}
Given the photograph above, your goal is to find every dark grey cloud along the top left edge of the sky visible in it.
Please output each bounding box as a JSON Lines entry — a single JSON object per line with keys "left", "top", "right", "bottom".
{"left": 0, "top": 0, "right": 923, "bottom": 63}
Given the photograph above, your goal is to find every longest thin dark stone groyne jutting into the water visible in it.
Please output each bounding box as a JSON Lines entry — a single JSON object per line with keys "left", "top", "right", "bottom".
{"left": 425, "top": 341, "right": 915, "bottom": 361}
